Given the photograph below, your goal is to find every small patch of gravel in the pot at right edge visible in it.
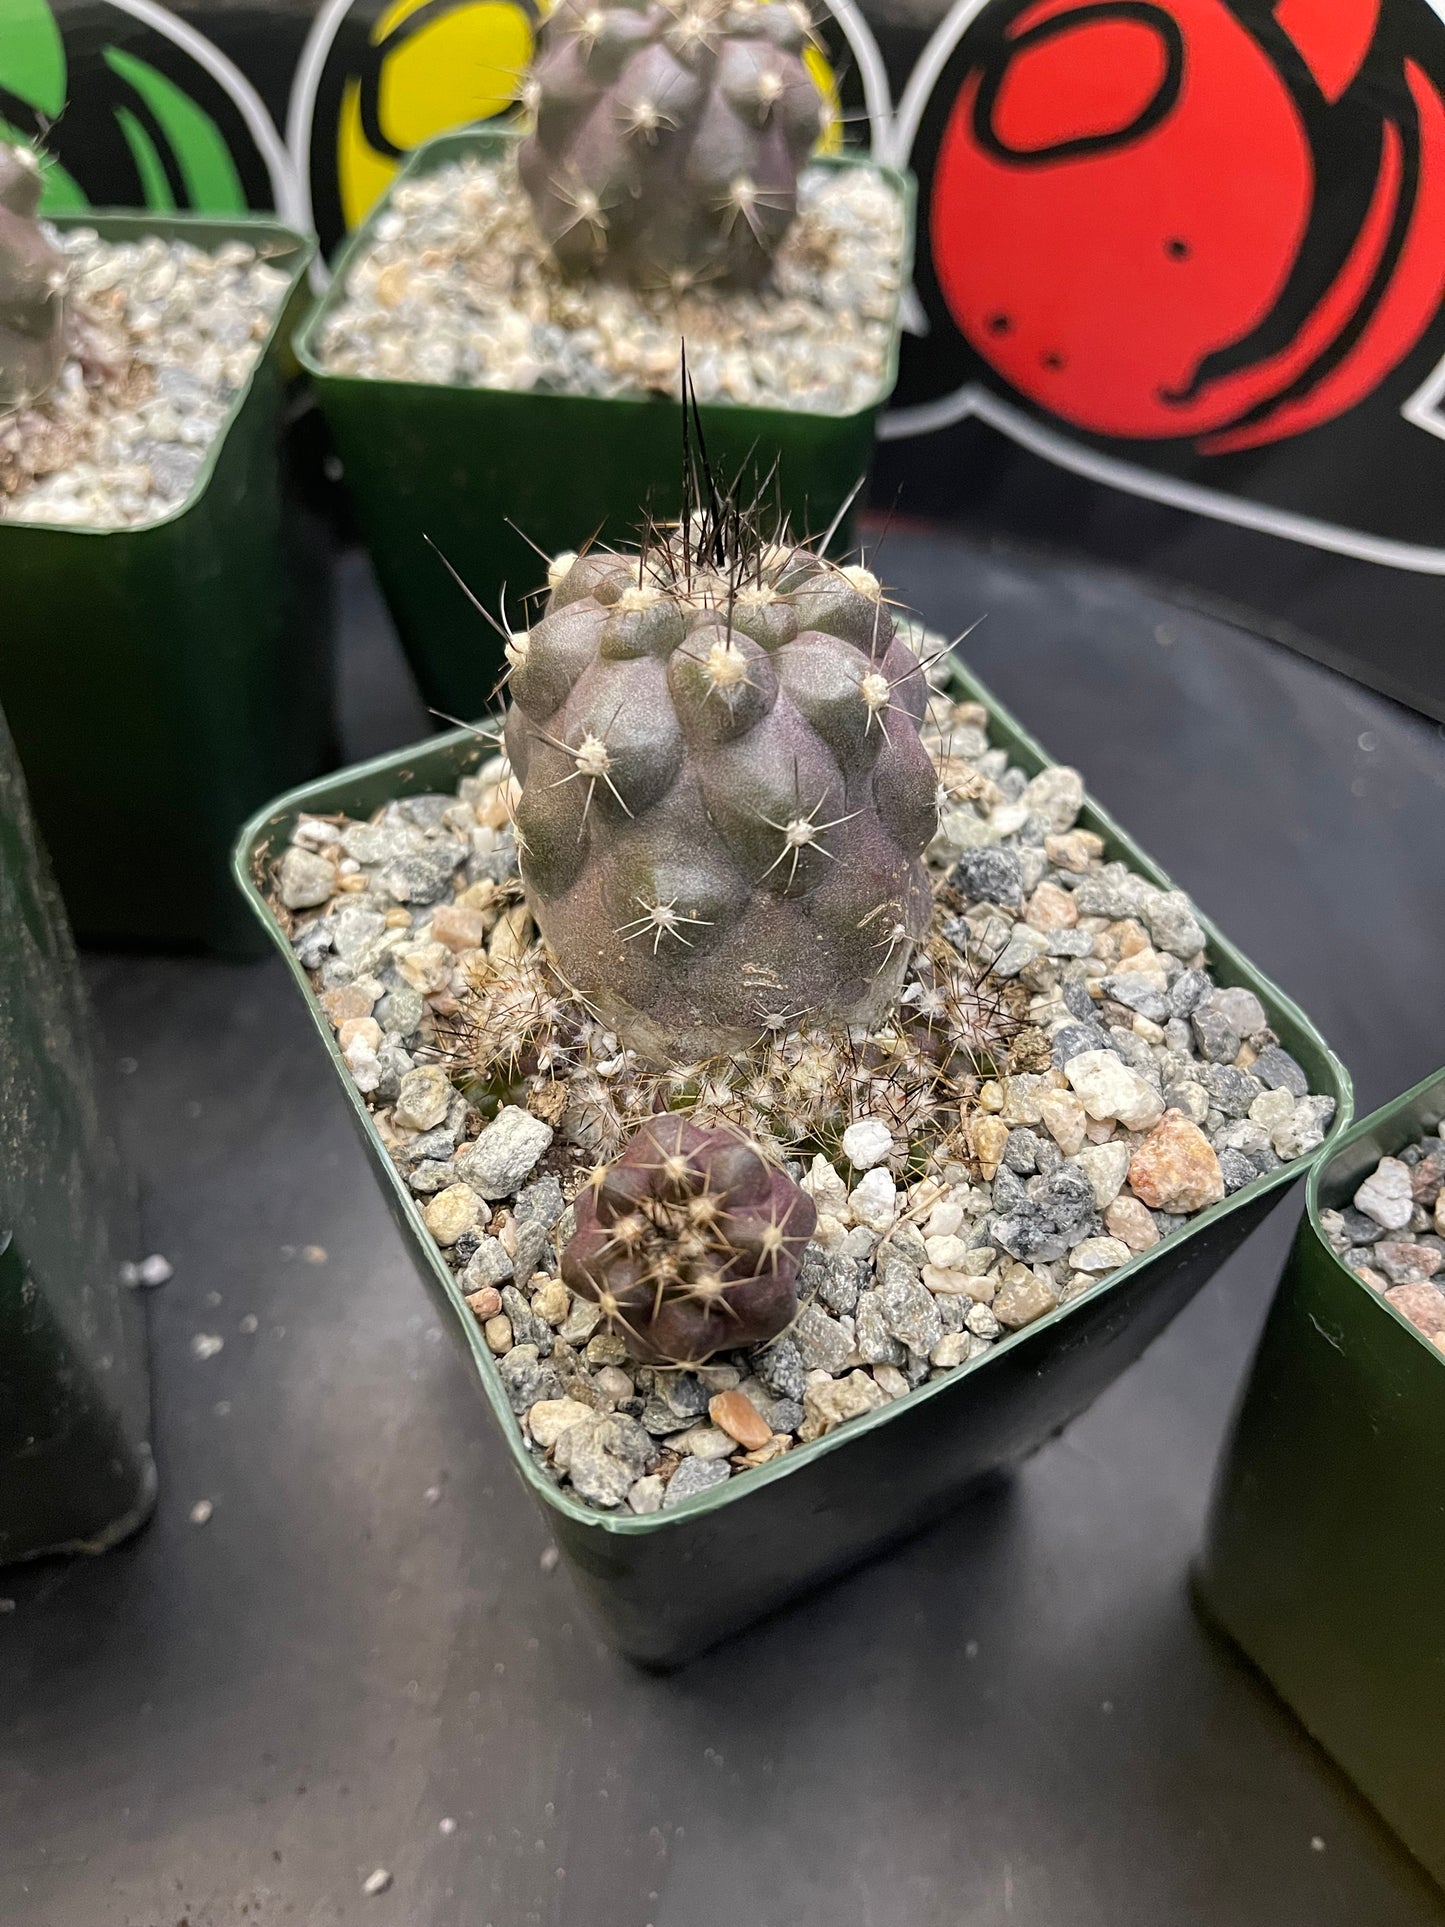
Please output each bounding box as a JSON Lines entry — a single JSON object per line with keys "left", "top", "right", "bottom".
{"left": 1320, "top": 1122, "right": 1445, "bottom": 1351}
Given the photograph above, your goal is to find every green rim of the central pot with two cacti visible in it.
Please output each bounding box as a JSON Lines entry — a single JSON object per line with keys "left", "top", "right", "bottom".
{"left": 233, "top": 647, "right": 1356, "bottom": 1536}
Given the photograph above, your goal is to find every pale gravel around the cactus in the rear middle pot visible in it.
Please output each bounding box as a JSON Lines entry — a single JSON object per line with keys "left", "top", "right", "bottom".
{"left": 320, "top": 158, "right": 904, "bottom": 414}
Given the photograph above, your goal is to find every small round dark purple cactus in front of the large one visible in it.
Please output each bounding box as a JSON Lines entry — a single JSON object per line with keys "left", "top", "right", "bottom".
{"left": 563, "top": 1116, "right": 817, "bottom": 1364}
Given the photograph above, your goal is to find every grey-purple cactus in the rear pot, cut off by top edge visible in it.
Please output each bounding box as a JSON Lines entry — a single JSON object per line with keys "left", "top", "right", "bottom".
{"left": 518, "top": 0, "right": 823, "bottom": 293}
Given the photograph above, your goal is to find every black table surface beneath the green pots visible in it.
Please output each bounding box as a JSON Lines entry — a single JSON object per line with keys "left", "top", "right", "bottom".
{"left": 0, "top": 530, "right": 1445, "bottom": 1927}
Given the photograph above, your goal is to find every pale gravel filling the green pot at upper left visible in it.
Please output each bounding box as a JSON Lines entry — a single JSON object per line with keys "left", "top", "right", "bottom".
{"left": 0, "top": 227, "right": 289, "bottom": 528}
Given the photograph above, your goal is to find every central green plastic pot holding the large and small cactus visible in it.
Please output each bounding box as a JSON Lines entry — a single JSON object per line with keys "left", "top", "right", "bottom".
{"left": 235, "top": 669, "right": 1351, "bottom": 1667}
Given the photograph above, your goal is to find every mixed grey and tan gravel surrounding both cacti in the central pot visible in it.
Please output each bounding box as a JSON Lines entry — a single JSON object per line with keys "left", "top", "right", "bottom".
{"left": 276, "top": 655, "right": 1340, "bottom": 1513}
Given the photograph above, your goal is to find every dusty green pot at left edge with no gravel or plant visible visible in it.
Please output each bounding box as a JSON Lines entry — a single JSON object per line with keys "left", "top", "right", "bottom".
{"left": 0, "top": 701, "right": 156, "bottom": 1563}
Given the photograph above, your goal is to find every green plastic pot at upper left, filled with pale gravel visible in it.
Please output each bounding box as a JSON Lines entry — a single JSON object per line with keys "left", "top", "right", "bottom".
{"left": 0, "top": 214, "right": 333, "bottom": 956}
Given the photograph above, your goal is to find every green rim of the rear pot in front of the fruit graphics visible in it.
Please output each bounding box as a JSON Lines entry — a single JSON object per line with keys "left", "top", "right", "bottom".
{"left": 293, "top": 121, "right": 917, "bottom": 424}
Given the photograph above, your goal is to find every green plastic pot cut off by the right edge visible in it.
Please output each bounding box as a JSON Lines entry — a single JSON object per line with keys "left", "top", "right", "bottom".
{"left": 1195, "top": 1071, "right": 1445, "bottom": 1883}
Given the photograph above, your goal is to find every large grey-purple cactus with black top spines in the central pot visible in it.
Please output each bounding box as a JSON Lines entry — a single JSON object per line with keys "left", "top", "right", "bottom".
{"left": 507, "top": 484, "right": 936, "bottom": 1066}
